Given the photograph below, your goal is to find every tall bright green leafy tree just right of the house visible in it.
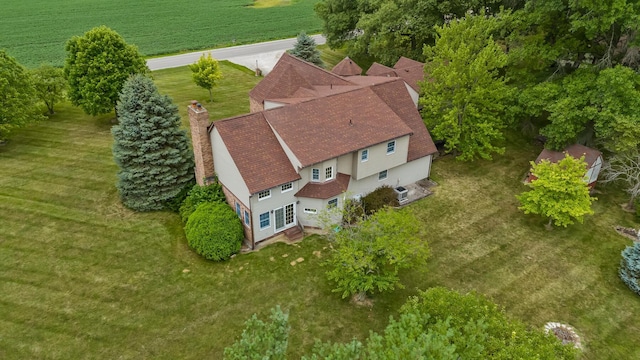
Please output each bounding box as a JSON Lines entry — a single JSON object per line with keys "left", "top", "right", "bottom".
{"left": 420, "top": 14, "right": 512, "bottom": 160}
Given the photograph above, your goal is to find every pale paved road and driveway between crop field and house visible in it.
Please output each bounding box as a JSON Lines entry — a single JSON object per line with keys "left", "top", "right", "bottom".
{"left": 147, "top": 35, "right": 326, "bottom": 73}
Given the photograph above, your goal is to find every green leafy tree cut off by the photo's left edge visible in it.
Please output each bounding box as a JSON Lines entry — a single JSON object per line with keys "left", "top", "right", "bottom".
{"left": 0, "top": 50, "right": 41, "bottom": 142}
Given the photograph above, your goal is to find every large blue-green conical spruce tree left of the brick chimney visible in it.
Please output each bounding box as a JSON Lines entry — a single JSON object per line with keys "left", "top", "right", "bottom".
{"left": 111, "top": 74, "right": 193, "bottom": 211}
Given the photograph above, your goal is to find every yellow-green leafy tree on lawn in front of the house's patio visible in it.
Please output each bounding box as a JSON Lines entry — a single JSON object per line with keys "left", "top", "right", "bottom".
{"left": 327, "top": 209, "right": 429, "bottom": 299}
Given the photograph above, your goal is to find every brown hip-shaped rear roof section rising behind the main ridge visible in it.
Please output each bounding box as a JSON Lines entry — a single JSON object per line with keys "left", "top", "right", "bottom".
{"left": 249, "top": 53, "right": 351, "bottom": 102}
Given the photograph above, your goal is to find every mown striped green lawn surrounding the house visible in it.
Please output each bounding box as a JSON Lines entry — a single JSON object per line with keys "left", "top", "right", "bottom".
{"left": 0, "top": 63, "right": 640, "bottom": 359}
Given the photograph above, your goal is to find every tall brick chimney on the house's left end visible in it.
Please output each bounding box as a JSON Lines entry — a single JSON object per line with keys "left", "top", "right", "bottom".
{"left": 188, "top": 100, "right": 214, "bottom": 186}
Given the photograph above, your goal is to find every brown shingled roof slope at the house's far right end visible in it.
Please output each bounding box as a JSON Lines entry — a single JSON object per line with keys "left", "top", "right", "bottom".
{"left": 371, "top": 79, "right": 438, "bottom": 161}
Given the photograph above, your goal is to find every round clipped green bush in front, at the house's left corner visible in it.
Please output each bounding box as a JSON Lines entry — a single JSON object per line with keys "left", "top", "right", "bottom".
{"left": 184, "top": 202, "right": 244, "bottom": 261}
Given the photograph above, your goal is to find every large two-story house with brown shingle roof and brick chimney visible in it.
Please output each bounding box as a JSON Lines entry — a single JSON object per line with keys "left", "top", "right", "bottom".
{"left": 189, "top": 54, "right": 436, "bottom": 247}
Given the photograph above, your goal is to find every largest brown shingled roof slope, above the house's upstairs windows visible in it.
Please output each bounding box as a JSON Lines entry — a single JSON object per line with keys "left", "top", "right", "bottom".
{"left": 263, "top": 85, "right": 412, "bottom": 167}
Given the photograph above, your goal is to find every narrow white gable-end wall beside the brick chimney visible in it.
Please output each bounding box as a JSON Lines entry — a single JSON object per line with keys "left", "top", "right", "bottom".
{"left": 209, "top": 126, "right": 250, "bottom": 204}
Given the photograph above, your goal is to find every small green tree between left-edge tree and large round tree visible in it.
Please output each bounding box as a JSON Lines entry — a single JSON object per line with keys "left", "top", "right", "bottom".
{"left": 31, "top": 64, "right": 67, "bottom": 115}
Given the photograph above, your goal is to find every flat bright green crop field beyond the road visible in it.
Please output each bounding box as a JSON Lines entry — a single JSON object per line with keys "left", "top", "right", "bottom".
{"left": 0, "top": 0, "right": 321, "bottom": 67}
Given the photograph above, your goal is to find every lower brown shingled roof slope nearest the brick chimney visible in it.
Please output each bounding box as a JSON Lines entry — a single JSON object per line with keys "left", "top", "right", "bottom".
{"left": 212, "top": 112, "right": 300, "bottom": 194}
